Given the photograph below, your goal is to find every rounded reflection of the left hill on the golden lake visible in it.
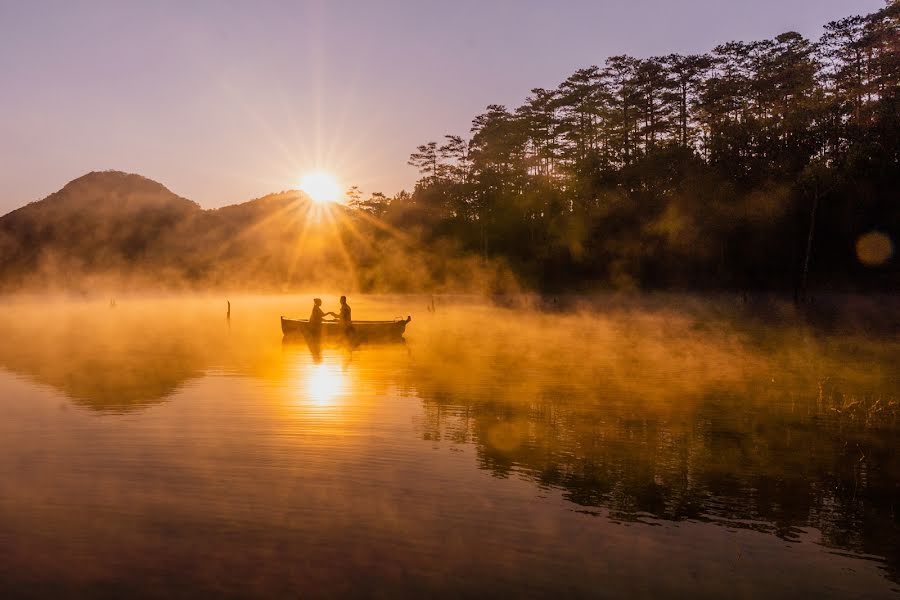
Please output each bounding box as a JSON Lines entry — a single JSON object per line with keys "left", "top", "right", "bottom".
{"left": 0, "top": 303, "right": 207, "bottom": 413}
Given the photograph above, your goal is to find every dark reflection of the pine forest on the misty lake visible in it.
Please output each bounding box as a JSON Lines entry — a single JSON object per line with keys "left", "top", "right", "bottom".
{"left": 400, "top": 304, "right": 900, "bottom": 581}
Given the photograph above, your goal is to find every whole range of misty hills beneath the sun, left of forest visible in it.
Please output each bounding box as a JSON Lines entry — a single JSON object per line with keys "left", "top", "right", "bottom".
{"left": 0, "top": 171, "right": 506, "bottom": 293}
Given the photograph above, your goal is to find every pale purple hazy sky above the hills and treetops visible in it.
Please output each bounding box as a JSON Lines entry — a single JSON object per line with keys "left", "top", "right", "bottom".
{"left": 0, "top": 0, "right": 884, "bottom": 214}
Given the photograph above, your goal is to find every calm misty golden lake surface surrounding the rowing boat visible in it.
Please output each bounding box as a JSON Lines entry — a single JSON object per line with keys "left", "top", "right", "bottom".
{"left": 0, "top": 297, "right": 900, "bottom": 598}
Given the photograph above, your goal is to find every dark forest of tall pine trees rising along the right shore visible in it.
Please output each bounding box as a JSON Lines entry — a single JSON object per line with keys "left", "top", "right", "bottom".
{"left": 348, "top": 1, "right": 900, "bottom": 298}
